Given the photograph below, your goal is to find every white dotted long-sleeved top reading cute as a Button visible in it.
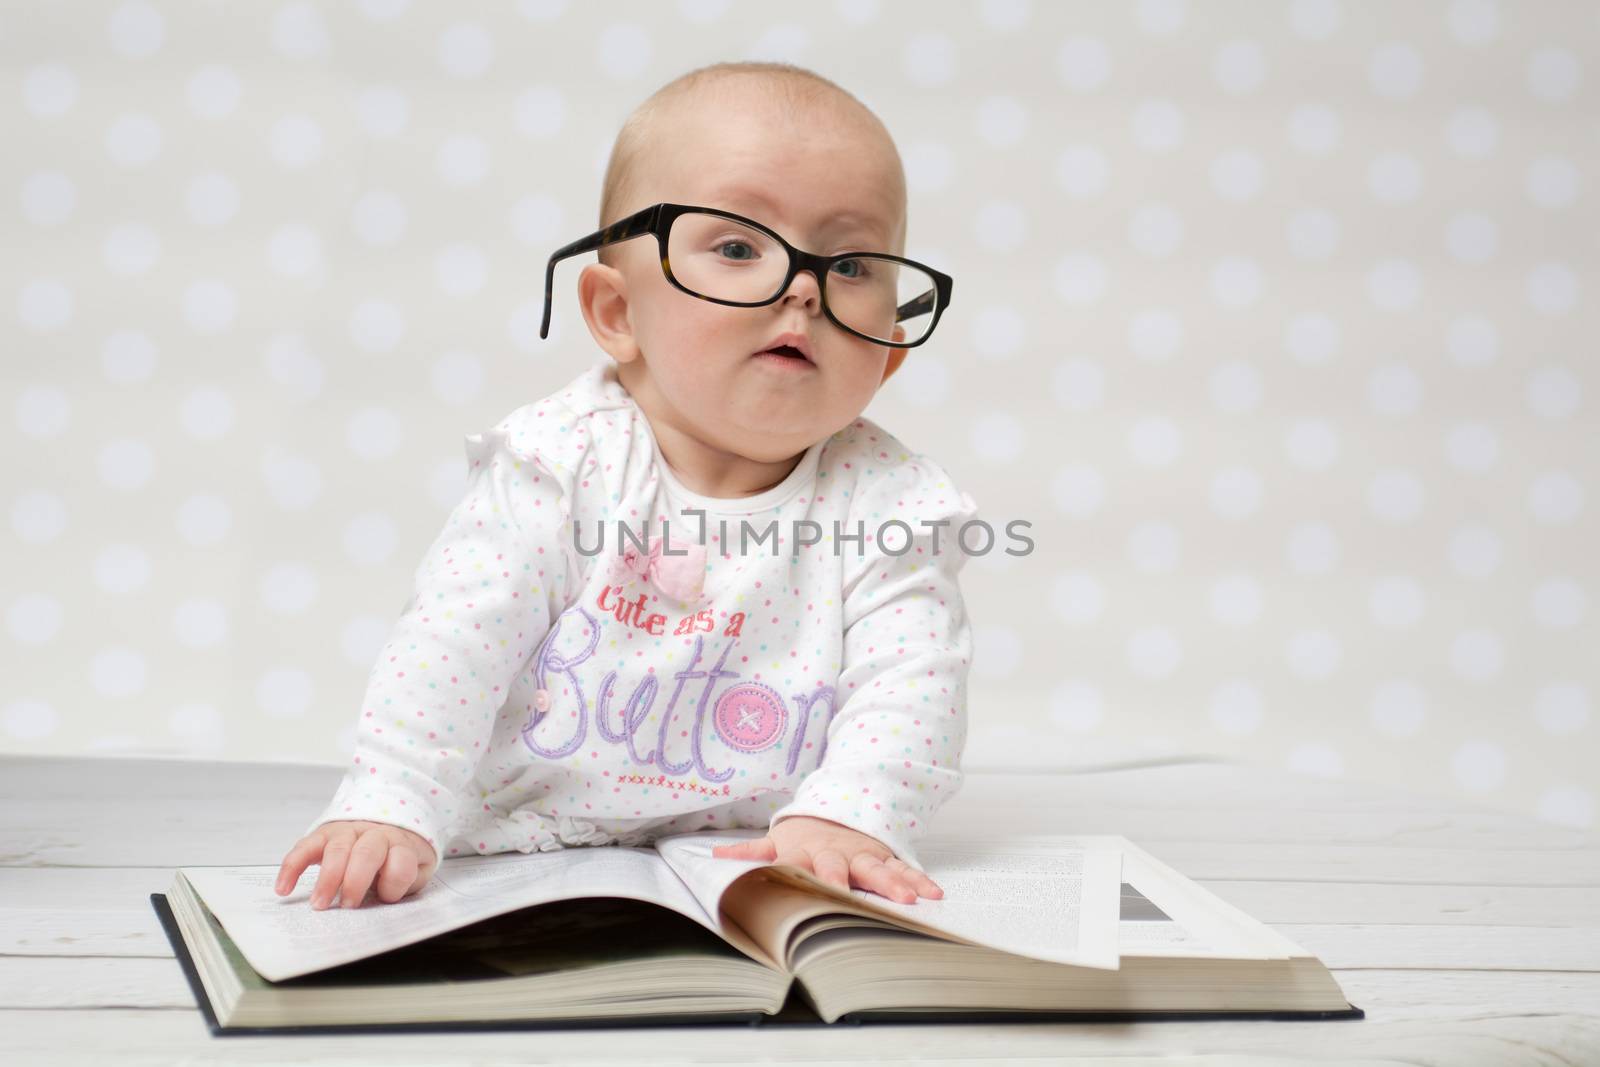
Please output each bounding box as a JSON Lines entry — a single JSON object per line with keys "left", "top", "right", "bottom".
{"left": 300, "top": 360, "right": 976, "bottom": 865}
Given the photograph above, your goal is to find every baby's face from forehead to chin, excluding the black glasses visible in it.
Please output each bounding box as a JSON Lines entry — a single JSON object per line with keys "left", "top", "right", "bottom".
{"left": 589, "top": 98, "right": 906, "bottom": 462}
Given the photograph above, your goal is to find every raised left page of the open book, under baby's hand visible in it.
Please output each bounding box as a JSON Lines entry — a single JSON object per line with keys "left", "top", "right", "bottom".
{"left": 181, "top": 845, "right": 717, "bottom": 982}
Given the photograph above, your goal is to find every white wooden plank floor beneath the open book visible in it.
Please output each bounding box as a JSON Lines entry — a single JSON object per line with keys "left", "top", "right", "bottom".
{"left": 0, "top": 757, "right": 1600, "bottom": 1067}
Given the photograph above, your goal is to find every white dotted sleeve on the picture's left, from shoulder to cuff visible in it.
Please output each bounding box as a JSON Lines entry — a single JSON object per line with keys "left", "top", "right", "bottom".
{"left": 307, "top": 429, "right": 578, "bottom": 856}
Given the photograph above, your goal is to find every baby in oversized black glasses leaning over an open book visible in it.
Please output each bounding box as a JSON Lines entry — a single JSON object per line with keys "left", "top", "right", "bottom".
{"left": 275, "top": 62, "right": 976, "bottom": 909}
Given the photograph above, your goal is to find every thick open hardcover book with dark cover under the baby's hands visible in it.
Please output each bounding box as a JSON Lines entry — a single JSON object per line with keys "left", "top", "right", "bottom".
{"left": 150, "top": 830, "right": 1362, "bottom": 1033}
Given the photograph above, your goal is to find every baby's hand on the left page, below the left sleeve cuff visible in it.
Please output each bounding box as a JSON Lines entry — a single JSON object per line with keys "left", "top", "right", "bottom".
{"left": 274, "top": 821, "right": 437, "bottom": 910}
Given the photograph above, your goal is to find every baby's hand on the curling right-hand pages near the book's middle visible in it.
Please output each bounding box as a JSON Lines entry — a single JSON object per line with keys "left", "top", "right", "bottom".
{"left": 710, "top": 816, "right": 944, "bottom": 904}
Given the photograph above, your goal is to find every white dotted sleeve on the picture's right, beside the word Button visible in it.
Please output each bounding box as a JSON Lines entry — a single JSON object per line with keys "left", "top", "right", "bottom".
{"left": 771, "top": 456, "right": 976, "bottom": 867}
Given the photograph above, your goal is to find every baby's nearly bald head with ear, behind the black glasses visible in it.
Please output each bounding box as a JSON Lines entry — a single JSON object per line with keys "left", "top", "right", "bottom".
{"left": 578, "top": 62, "right": 928, "bottom": 464}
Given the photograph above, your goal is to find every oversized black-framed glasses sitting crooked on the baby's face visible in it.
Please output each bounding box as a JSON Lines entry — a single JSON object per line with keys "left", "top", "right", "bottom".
{"left": 539, "top": 203, "right": 954, "bottom": 349}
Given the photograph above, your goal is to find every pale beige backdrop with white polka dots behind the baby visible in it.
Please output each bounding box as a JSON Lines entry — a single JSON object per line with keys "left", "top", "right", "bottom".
{"left": 0, "top": 0, "right": 1600, "bottom": 825}
